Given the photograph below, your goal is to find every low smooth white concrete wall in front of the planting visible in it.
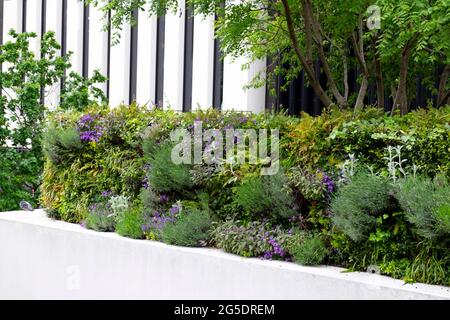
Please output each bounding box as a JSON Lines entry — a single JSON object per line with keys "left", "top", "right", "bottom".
{"left": 0, "top": 210, "right": 450, "bottom": 299}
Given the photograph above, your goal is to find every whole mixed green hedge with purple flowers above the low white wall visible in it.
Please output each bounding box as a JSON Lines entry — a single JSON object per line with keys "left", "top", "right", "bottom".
{"left": 41, "top": 105, "right": 450, "bottom": 285}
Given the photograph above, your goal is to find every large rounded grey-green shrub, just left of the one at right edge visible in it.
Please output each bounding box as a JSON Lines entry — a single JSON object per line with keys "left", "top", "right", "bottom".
{"left": 331, "top": 172, "right": 392, "bottom": 241}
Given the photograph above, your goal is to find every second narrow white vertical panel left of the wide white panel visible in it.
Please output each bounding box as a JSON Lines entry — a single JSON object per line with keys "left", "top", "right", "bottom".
{"left": 163, "top": 0, "right": 185, "bottom": 111}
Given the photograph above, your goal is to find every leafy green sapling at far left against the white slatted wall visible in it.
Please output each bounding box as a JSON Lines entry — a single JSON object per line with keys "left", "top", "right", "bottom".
{"left": 0, "top": 30, "right": 106, "bottom": 211}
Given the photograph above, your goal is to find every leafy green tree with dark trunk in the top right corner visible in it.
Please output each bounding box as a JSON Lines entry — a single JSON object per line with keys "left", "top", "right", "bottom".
{"left": 377, "top": 0, "right": 450, "bottom": 114}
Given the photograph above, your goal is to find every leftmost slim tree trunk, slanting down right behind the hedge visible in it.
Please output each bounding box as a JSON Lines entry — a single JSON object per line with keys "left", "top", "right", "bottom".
{"left": 281, "top": 0, "right": 333, "bottom": 107}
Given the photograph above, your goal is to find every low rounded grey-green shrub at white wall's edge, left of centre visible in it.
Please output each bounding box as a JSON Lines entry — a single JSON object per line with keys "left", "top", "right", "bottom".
{"left": 161, "top": 209, "right": 211, "bottom": 247}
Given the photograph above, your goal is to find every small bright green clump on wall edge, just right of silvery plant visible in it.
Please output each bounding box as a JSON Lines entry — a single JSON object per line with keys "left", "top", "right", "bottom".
{"left": 116, "top": 205, "right": 144, "bottom": 239}
